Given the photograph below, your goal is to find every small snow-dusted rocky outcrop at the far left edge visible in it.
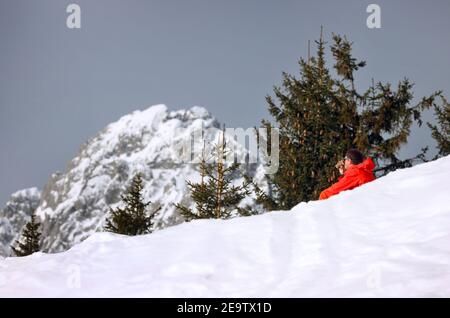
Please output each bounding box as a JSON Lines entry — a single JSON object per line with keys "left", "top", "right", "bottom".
{"left": 0, "top": 188, "right": 41, "bottom": 256}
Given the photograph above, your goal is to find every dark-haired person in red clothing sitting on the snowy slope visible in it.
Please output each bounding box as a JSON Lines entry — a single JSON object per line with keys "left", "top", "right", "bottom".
{"left": 319, "top": 149, "right": 375, "bottom": 200}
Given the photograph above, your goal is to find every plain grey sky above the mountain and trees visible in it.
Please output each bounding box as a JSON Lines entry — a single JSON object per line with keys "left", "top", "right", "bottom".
{"left": 0, "top": 0, "right": 450, "bottom": 205}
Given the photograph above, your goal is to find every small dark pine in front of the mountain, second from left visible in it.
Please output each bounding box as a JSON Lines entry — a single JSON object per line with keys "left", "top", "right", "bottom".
{"left": 105, "top": 173, "right": 159, "bottom": 235}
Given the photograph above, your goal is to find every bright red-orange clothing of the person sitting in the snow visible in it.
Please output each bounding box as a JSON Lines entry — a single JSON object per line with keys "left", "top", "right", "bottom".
{"left": 319, "top": 158, "right": 375, "bottom": 200}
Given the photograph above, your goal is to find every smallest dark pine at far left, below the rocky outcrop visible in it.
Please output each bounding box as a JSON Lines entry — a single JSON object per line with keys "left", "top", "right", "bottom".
{"left": 11, "top": 214, "right": 41, "bottom": 256}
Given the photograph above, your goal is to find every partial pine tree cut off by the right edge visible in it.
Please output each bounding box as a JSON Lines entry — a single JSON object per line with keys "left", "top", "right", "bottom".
{"left": 427, "top": 97, "right": 450, "bottom": 157}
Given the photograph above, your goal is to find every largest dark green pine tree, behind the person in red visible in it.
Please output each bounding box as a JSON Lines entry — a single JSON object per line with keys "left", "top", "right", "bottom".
{"left": 263, "top": 32, "right": 441, "bottom": 209}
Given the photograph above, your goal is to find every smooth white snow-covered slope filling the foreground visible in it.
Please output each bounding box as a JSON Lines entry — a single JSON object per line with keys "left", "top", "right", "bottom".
{"left": 0, "top": 157, "right": 450, "bottom": 297}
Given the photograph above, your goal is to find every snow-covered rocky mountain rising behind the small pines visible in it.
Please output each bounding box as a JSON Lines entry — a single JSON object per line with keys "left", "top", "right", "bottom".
{"left": 0, "top": 105, "right": 264, "bottom": 255}
